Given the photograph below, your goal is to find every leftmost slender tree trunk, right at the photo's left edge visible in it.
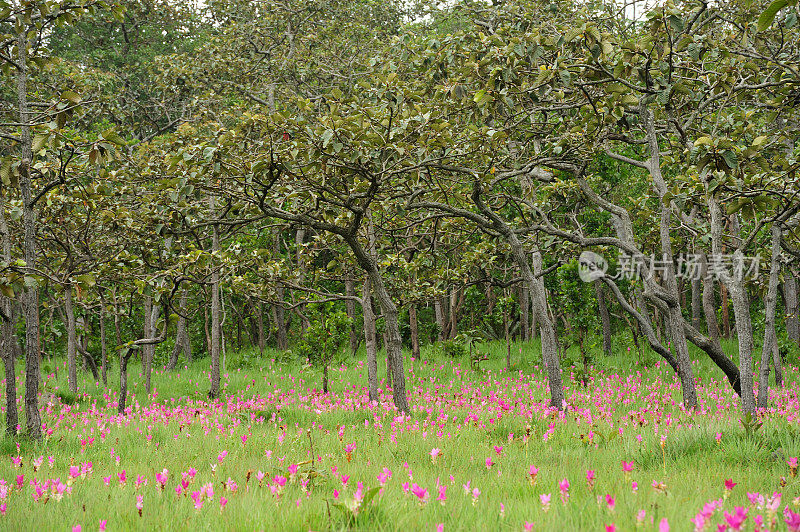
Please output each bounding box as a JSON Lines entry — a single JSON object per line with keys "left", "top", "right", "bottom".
{"left": 0, "top": 200, "right": 19, "bottom": 437}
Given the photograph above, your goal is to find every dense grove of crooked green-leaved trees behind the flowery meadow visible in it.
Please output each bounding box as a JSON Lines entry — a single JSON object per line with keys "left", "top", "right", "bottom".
{"left": 0, "top": 0, "right": 800, "bottom": 438}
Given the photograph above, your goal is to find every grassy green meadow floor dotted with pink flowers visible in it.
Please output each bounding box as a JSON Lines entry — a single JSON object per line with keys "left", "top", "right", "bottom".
{"left": 0, "top": 343, "right": 800, "bottom": 531}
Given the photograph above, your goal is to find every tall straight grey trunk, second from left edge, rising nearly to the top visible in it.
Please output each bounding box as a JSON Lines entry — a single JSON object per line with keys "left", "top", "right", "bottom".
{"left": 17, "top": 30, "right": 42, "bottom": 440}
